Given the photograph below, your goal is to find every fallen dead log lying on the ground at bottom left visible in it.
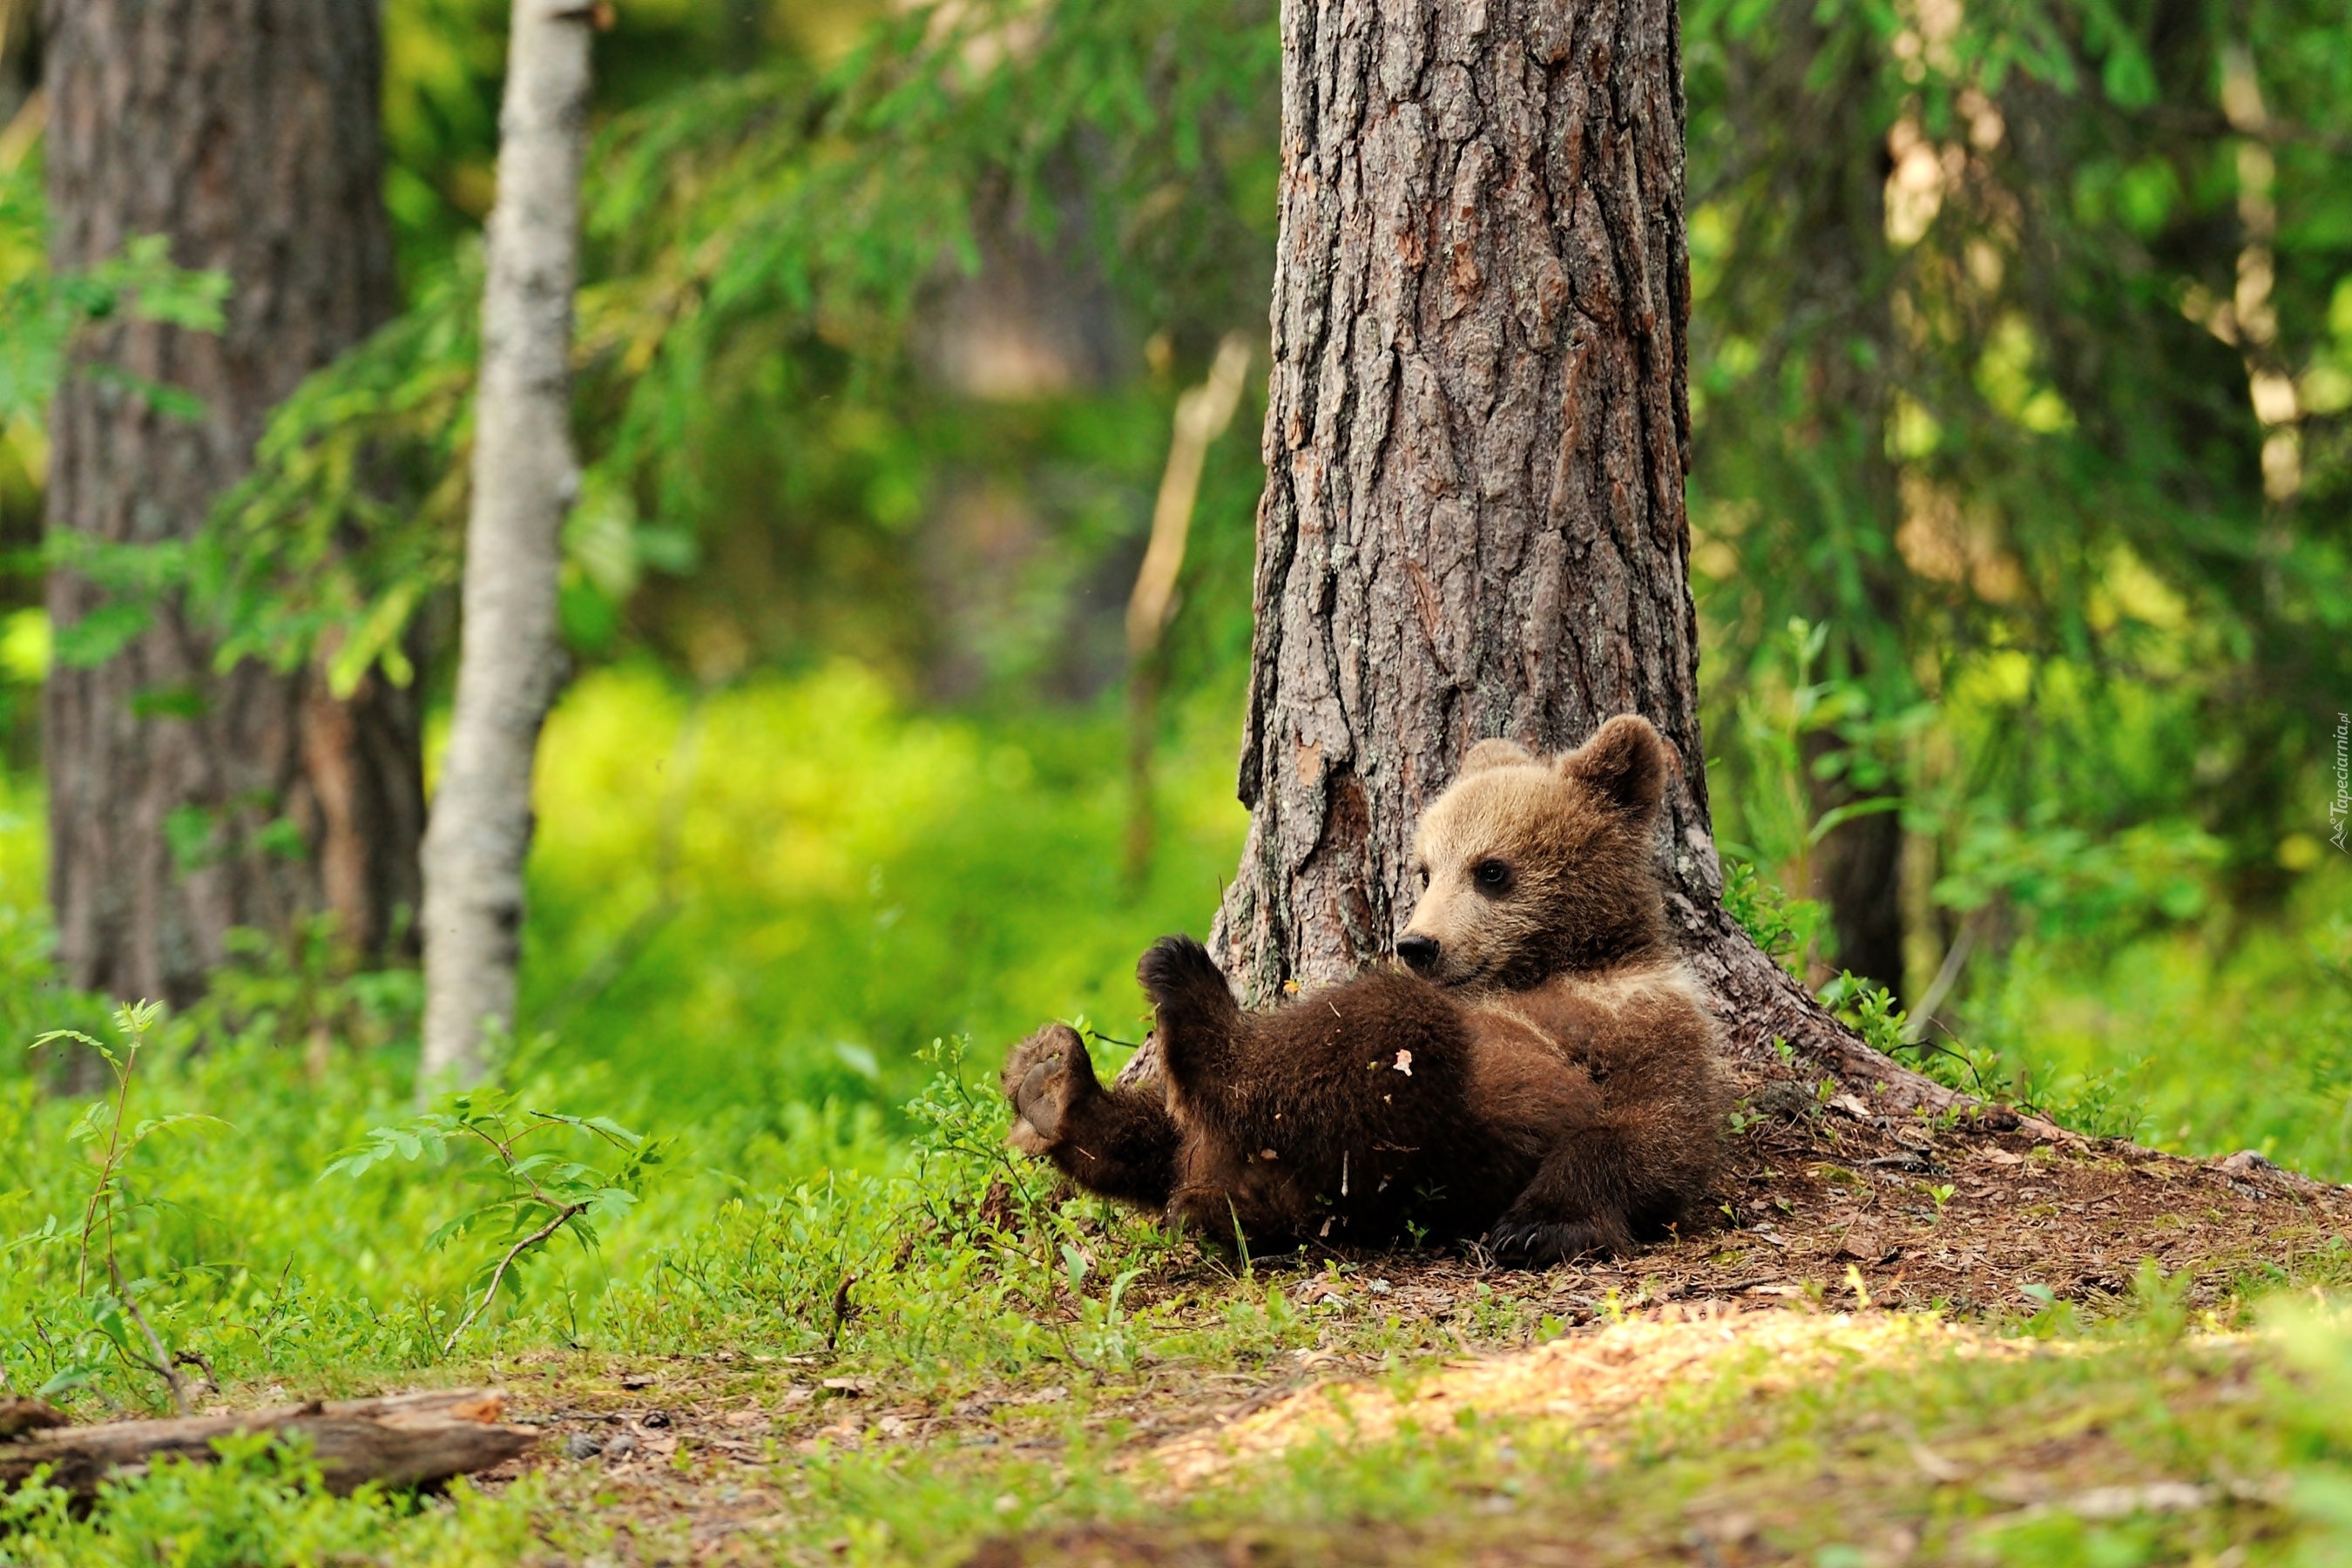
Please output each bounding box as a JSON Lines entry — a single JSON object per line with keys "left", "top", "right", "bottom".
{"left": 0, "top": 1389, "right": 538, "bottom": 1500}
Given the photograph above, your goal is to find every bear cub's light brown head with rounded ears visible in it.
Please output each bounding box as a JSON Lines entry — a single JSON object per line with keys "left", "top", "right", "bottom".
{"left": 1397, "top": 714, "right": 1674, "bottom": 990}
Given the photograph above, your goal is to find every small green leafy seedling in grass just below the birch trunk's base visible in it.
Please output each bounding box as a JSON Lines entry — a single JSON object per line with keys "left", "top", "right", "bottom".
{"left": 320, "top": 1088, "right": 668, "bottom": 1356}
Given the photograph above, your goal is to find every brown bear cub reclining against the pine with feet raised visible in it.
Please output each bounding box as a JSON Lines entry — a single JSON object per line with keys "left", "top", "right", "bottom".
{"left": 1004, "top": 717, "right": 1729, "bottom": 1265}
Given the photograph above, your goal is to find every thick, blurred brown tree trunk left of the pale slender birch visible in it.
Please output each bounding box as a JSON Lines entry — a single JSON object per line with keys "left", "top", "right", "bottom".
{"left": 43, "top": 0, "right": 423, "bottom": 1020}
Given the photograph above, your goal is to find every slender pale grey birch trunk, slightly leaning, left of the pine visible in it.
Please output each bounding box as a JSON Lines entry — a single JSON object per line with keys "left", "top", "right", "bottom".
{"left": 423, "top": 0, "right": 595, "bottom": 1081}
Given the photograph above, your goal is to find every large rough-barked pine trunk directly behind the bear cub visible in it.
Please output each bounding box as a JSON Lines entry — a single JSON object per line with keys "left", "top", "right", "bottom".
{"left": 1212, "top": 0, "right": 1950, "bottom": 1103}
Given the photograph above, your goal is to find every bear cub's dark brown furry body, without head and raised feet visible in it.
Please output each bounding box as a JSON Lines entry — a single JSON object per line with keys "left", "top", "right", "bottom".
{"left": 1169, "top": 963, "right": 1720, "bottom": 1251}
